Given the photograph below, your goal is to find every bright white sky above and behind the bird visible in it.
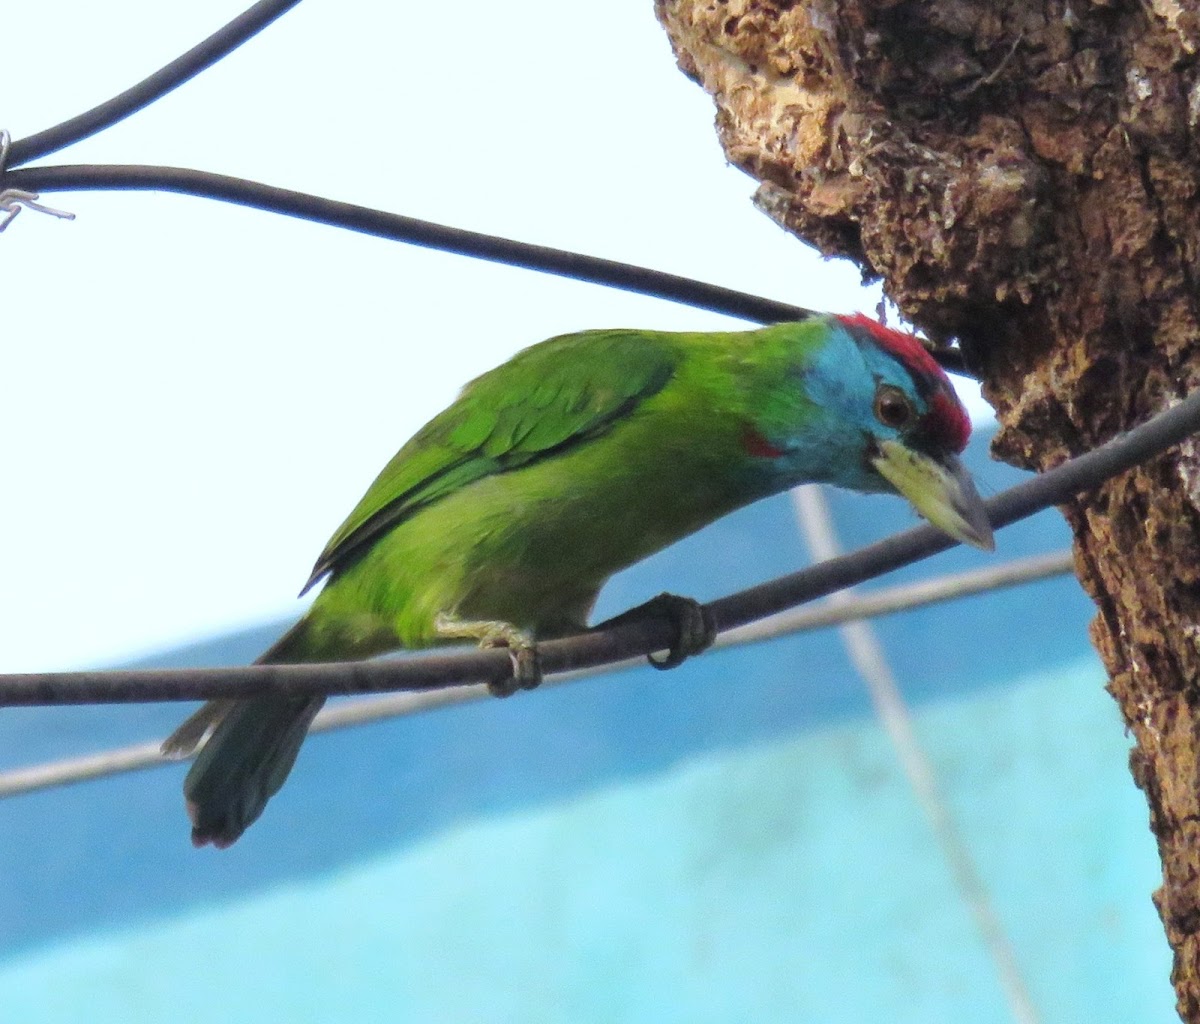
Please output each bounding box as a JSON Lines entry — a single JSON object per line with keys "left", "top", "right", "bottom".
{"left": 0, "top": 0, "right": 985, "bottom": 671}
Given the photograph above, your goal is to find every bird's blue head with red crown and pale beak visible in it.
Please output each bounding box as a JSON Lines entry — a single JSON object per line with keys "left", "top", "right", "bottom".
{"left": 768, "top": 315, "right": 995, "bottom": 551}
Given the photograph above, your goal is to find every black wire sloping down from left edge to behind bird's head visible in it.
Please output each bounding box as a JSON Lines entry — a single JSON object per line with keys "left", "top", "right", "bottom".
{"left": 5, "top": 164, "right": 967, "bottom": 375}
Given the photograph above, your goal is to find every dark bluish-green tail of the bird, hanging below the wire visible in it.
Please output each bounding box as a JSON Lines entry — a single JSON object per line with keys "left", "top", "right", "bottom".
{"left": 162, "top": 617, "right": 325, "bottom": 849}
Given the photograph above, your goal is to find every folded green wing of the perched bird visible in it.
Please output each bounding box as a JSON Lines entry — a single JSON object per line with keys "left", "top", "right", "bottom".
{"left": 301, "top": 330, "right": 678, "bottom": 593}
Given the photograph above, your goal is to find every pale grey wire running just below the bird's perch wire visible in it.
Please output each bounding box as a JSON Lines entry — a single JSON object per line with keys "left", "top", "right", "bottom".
{"left": 0, "top": 551, "right": 1072, "bottom": 798}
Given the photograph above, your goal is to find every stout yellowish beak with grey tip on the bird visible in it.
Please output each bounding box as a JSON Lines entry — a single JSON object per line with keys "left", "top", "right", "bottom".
{"left": 871, "top": 441, "right": 996, "bottom": 551}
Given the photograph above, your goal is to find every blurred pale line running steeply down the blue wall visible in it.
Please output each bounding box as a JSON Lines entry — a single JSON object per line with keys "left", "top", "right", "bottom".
{"left": 792, "top": 484, "right": 1039, "bottom": 1024}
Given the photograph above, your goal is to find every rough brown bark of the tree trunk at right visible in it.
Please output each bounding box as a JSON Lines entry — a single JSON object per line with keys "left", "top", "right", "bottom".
{"left": 656, "top": 0, "right": 1200, "bottom": 1024}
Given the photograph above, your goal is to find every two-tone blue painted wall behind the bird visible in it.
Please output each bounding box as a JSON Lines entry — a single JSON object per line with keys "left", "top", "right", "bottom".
{"left": 0, "top": 436, "right": 1175, "bottom": 1024}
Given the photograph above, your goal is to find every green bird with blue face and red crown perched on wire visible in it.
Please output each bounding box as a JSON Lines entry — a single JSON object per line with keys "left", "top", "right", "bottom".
{"left": 163, "top": 316, "right": 992, "bottom": 848}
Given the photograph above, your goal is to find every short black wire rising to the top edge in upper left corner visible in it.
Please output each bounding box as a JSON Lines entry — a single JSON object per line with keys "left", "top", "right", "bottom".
{"left": 8, "top": 0, "right": 300, "bottom": 168}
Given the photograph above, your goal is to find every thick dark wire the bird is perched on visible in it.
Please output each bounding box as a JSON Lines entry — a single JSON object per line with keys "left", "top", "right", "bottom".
{"left": 0, "top": 391, "right": 1200, "bottom": 706}
